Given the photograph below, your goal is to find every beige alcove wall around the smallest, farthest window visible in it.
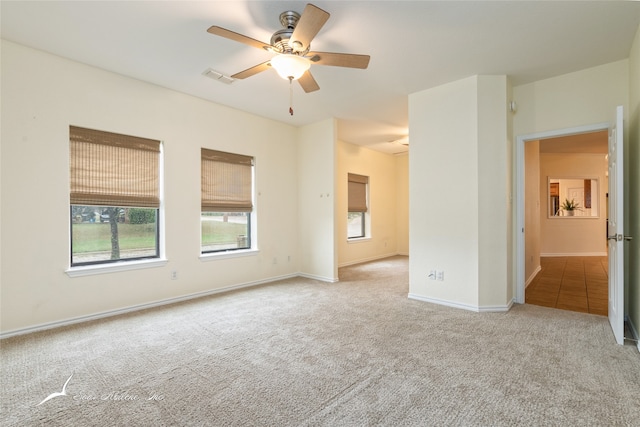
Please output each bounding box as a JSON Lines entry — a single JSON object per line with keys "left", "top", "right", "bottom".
{"left": 335, "top": 142, "right": 409, "bottom": 266}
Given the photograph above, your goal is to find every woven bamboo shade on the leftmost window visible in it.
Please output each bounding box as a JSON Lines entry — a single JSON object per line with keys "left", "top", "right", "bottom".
{"left": 69, "top": 126, "right": 160, "bottom": 208}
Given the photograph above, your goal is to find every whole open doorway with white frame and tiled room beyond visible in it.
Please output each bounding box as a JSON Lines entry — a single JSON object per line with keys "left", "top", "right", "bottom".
{"left": 516, "top": 124, "right": 609, "bottom": 315}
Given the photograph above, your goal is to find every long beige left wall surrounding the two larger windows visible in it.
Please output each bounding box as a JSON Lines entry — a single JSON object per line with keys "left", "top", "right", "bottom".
{"left": 0, "top": 41, "right": 302, "bottom": 333}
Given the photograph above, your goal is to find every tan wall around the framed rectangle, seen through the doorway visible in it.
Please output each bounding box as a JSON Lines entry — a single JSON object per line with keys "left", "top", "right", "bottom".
{"left": 527, "top": 153, "right": 607, "bottom": 256}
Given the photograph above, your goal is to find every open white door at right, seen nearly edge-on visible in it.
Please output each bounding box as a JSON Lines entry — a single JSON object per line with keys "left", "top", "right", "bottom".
{"left": 607, "top": 106, "right": 624, "bottom": 344}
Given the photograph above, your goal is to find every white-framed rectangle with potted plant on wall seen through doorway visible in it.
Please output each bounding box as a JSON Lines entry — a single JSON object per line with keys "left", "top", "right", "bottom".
{"left": 547, "top": 177, "right": 599, "bottom": 218}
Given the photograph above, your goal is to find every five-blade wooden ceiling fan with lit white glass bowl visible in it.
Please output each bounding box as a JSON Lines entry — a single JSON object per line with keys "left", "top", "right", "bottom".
{"left": 207, "top": 3, "right": 369, "bottom": 93}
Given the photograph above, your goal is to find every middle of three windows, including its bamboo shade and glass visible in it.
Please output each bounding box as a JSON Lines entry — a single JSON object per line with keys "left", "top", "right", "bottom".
{"left": 200, "top": 148, "right": 253, "bottom": 253}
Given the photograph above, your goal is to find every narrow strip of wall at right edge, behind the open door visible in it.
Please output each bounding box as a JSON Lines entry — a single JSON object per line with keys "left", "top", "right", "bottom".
{"left": 625, "top": 27, "right": 640, "bottom": 349}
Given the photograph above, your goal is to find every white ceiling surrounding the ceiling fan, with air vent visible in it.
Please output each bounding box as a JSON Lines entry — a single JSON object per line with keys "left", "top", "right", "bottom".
{"left": 0, "top": 0, "right": 640, "bottom": 153}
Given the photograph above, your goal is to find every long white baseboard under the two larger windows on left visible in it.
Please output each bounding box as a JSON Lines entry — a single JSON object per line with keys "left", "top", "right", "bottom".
{"left": 0, "top": 274, "right": 301, "bottom": 340}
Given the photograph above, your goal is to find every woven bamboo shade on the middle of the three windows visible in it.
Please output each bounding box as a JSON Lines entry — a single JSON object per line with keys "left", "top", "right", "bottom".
{"left": 201, "top": 148, "right": 253, "bottom": 212}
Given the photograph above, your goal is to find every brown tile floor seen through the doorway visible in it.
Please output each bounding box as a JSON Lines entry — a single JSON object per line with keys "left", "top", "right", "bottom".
{"left": 525, "top": 256, "right": 609, "bottom": 316}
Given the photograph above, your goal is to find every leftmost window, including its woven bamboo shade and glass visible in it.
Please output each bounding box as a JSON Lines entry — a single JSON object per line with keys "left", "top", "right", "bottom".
{"left": 69, "top": 126, "right": 160, "bottom": 266}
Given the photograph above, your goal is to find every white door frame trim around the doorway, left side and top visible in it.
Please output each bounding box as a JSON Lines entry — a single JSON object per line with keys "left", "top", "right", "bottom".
{"left": 514, "top": 123, "right": 611, "bottom": 304}
